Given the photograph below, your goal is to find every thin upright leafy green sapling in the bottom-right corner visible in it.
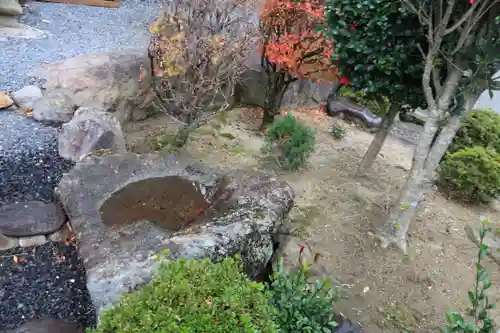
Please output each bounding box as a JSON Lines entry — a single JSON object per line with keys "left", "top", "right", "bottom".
{"left": 443, "top": 218, "right": 495, "bottom": 333}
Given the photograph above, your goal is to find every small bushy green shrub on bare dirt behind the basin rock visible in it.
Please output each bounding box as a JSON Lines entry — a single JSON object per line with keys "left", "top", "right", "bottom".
{"left": 266, "top": 115, "right": 316, "bottom": 170}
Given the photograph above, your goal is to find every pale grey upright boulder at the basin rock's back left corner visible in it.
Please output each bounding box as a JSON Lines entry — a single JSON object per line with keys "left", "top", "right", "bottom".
{"left": 58, "top": 107, "right": 126, "bottom": 162}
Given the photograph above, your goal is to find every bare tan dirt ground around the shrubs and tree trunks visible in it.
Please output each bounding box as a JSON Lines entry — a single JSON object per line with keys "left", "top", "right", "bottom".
{"left": 124, "top": 109, "right": 500, "bottom": 333}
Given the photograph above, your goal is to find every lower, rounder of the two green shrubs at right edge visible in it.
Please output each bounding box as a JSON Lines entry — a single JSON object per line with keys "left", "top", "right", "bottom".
{"left": 438, "top": 146, "right": 500, "bottom": 202}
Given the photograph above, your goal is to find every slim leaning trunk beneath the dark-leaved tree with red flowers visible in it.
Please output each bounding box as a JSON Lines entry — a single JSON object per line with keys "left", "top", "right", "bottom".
{"left": 357, "top": 104, "right": 400, "bottom": 175}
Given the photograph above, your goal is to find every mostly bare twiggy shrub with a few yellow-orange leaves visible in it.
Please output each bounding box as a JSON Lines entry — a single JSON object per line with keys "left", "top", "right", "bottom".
{"left": 150, "top": 0, "right": 257, "bottom": 127}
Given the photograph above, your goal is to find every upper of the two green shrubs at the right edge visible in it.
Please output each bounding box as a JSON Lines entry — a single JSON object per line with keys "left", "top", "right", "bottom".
{"left": 448, "top": 110, "right": 500, "bottom": 153}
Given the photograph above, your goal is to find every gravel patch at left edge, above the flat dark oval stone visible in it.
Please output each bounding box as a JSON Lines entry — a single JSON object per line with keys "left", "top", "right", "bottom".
{"left": 0, "top": 110, "right": 73, "bottom": 205}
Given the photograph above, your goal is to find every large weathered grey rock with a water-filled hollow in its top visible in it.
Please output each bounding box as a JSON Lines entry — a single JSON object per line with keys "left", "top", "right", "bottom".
{"left": 56, "top": 153, "right": 294, "bottom": 309}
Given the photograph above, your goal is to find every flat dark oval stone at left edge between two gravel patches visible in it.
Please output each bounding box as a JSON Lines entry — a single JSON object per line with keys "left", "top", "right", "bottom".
{"left": 0, "top": 201, "right": 67, "bottom": 237}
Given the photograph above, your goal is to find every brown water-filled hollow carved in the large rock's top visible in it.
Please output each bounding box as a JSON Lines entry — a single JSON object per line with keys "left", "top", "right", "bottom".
{"left": 100, "top": 176, "right": 224, "bottom": 231}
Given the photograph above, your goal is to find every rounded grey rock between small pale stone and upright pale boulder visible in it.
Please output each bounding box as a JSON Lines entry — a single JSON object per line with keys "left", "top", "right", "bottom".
{"left": 33, "top": 89, "right": 76, "bottom": 124}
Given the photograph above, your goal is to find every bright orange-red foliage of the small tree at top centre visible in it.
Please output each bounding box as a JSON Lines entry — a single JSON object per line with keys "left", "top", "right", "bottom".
{"left": 260, "top": 0, "right": 337, "bottom": 81}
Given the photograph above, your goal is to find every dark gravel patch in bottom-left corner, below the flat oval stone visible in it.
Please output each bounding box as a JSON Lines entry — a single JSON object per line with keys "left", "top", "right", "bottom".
{"left": 0, "top": 242, "right": 96, "bottom": 333}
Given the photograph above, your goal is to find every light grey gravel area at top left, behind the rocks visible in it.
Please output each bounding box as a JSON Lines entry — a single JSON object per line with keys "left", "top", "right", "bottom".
{"left": 0, "top": 0, "right": 160, "bottom": 91}
